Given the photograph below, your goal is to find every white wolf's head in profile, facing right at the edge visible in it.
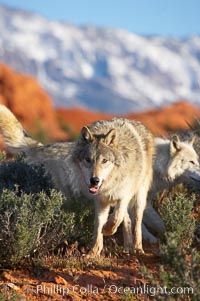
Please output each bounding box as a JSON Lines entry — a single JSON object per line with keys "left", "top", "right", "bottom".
{"left": 167, "top": 136, "right": 200, "bottom": 182}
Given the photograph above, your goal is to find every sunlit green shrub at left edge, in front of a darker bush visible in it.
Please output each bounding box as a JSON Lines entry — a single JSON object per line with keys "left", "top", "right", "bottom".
{"left": 0, "top": 190, "right": 73, "bottom": 267}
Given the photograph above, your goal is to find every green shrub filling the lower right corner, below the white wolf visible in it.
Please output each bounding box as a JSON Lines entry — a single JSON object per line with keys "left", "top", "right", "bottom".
{"left": 141, "top": 191, "right": 200, "bottom": 300}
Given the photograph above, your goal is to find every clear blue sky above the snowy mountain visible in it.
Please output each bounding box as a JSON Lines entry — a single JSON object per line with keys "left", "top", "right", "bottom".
{"left": 0, "top": 0, "right": 200, "bottom": 37}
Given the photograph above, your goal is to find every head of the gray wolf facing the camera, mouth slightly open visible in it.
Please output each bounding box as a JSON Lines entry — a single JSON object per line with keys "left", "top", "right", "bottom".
{"left": 76, "top": 127, "right": 117, "bottom": 194}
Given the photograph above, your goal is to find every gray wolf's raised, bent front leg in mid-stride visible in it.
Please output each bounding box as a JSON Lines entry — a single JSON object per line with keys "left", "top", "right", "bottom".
{"left": 103, "top": 199, "right": 130, "bottom": 236}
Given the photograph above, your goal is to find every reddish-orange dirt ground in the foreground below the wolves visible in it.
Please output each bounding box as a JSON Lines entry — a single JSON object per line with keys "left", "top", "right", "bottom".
{"left": 0, "top": 245, "right": 160, "bottom": 301}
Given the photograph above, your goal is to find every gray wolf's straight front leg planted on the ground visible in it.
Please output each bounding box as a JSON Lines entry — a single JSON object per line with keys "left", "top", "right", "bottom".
{"left": 89, "top": 201, "right": 110, "bottom": 256}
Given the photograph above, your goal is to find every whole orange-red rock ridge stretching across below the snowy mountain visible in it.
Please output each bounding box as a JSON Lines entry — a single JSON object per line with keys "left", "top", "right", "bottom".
{"left": 0, "top": 64, "right": 200, "bottom": 143}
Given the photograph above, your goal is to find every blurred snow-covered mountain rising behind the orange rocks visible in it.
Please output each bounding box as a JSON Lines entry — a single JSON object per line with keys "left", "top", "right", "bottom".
{"left": 0, "top": 6, "right": 200, "bottom": 113}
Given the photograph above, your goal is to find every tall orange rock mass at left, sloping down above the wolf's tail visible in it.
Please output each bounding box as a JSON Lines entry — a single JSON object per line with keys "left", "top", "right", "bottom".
{"left": 0, "top": 64, "right": 67, "bottom": 140}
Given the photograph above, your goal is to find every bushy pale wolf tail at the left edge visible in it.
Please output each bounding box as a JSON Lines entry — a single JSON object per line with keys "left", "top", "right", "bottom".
{"left": 0, "top": 105, "right": 42, "bottom": 152}
